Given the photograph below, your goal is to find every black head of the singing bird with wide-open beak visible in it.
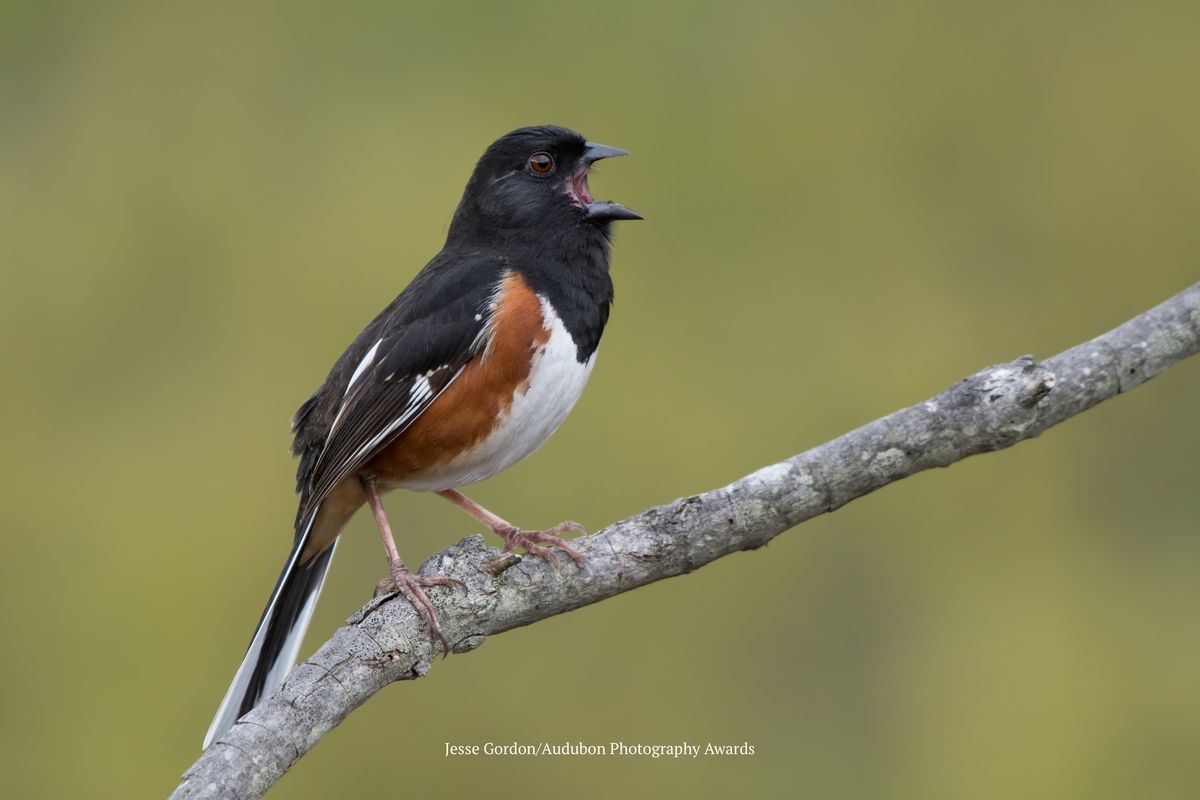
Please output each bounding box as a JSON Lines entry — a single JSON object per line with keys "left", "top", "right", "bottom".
{"left": 450, "top": 125, "right": 642, "bottom": 244}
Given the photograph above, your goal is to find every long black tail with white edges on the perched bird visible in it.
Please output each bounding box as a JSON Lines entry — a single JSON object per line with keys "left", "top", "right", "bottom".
{"left": 204, "top": 515, "right": 337, "bottom": 747}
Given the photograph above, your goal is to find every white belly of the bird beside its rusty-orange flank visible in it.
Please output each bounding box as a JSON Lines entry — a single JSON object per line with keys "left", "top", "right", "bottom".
{"left": 400, "top": 300, "right": 595, "bottom": 492}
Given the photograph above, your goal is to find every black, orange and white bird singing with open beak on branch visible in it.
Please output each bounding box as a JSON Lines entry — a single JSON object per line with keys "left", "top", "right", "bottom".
{"left": 204, "top": 126, "right": 642, "bottom": 747}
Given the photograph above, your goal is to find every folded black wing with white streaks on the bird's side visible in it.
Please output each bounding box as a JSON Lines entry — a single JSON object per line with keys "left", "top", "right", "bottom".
{"left": 293, "top": 251, "right": 505, "bottom": 527}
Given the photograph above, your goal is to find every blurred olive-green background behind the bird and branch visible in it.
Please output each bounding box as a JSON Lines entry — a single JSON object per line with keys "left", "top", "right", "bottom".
{"left": 0, "top": 0, "right": 1200, "bottom": 800}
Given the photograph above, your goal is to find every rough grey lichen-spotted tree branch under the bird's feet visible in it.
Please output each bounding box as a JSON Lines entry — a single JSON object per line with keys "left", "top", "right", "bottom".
{"left": 172, "top": 283, "right": 1200, "bottom": 800}
